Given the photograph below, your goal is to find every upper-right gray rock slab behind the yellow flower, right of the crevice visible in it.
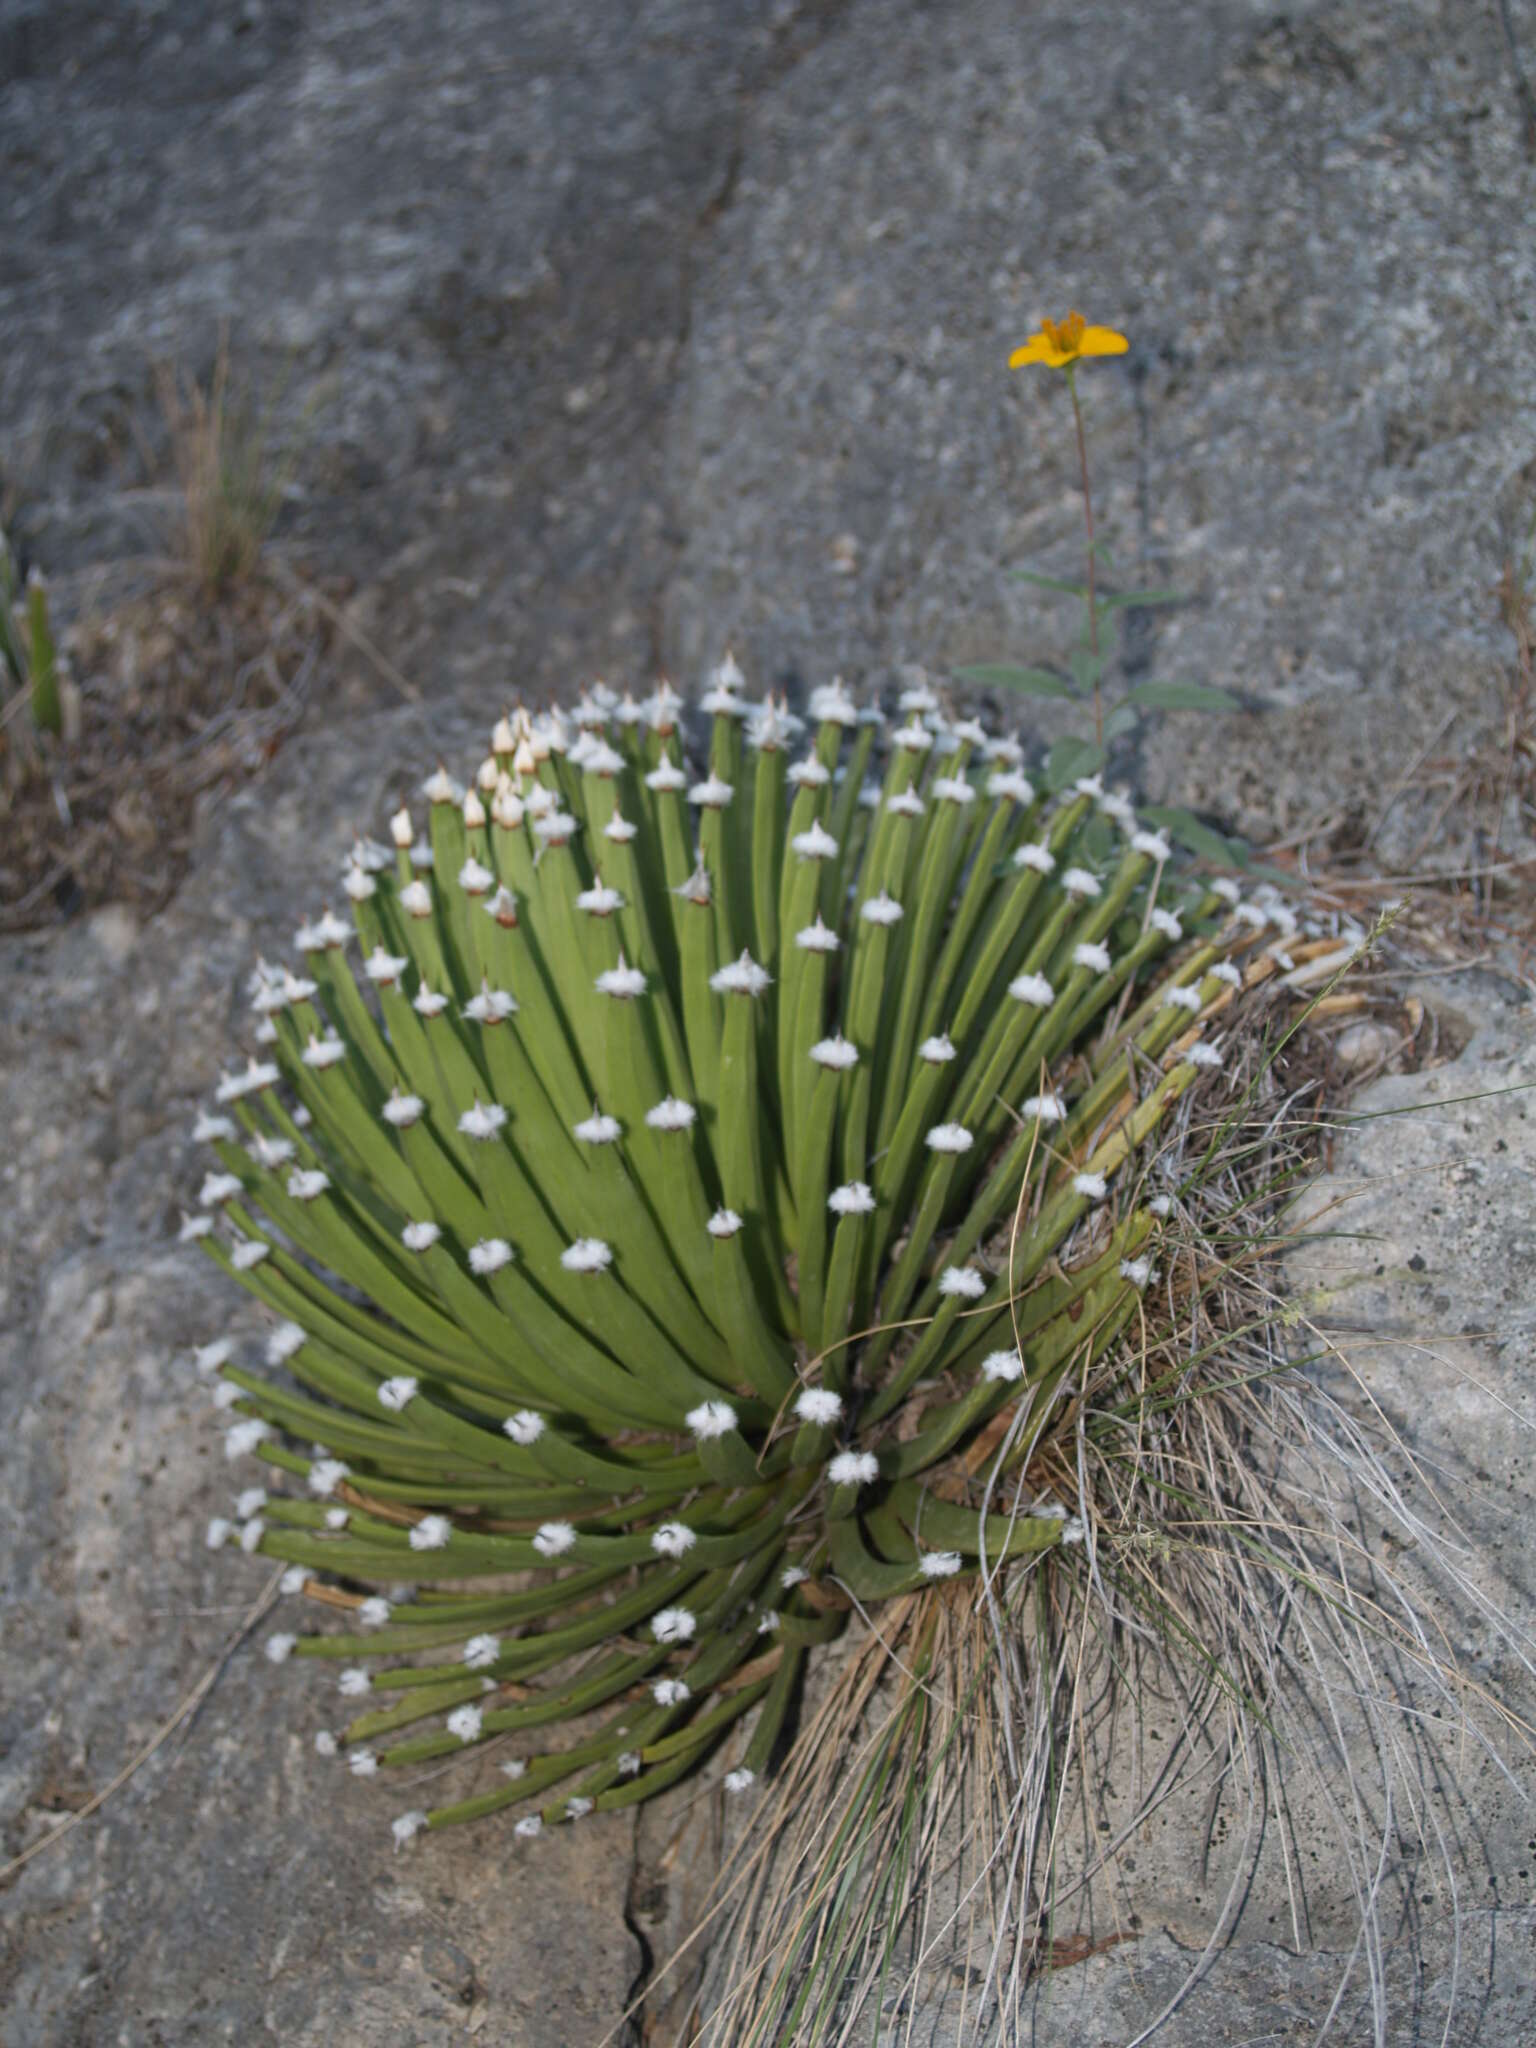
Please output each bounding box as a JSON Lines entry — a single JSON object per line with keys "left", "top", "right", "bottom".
{"left": 668, "top": 0, "right": 1536, "bottom": 851}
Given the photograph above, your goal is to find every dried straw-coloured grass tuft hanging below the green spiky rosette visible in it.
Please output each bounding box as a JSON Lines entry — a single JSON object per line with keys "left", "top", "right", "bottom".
{"left": 675, "top": 962, "right": 1536, "bottom": 2048}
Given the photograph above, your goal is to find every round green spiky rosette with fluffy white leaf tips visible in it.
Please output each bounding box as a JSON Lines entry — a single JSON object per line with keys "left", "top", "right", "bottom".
{"left": 186, "top": 664, "right": 1288, "bottom": 1835}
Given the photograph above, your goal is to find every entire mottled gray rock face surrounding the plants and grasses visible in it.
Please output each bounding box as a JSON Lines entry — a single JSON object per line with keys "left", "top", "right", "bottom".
{"left": 0, "top": 0, "right": 1536, "bottom": 2048}
